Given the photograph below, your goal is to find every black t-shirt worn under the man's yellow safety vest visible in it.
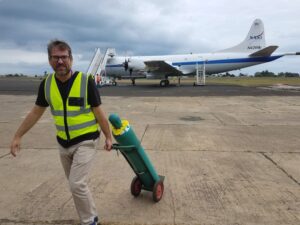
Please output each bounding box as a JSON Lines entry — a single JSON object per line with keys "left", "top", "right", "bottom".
{"left": 35, "top": 72, "right": 101, "bottom": 148}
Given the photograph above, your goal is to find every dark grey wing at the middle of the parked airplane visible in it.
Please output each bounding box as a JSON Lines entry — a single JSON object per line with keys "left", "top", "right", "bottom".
{"left": 144, "top": 60, "right": 183, "bottom": 76}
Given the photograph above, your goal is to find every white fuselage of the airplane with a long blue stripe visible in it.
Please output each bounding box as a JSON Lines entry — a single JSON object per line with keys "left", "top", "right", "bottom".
{"left": 106, "top": 53, "right": 283, "bottom": 79}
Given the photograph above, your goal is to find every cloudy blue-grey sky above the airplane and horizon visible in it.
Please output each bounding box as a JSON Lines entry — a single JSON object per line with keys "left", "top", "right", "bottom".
{"left": 0, "top": 0, "right": 300, "bottom": 75}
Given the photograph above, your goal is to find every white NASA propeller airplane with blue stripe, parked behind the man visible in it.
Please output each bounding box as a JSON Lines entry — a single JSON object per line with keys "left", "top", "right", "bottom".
{"left": 88, "top": 19, "right": 300, "bottom": 86}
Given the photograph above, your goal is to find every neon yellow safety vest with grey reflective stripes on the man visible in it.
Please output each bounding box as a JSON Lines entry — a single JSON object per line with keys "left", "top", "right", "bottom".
{"left": 45, "top": 72, "right": 98, "bottom": 140}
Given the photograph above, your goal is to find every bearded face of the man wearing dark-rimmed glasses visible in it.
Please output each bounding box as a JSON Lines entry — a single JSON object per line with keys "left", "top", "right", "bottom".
{"left": 49, "top": 47, "right": 73, "bottom": 77}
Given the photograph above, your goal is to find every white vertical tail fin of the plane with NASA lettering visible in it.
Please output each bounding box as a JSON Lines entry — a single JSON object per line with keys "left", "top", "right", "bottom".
{"left": 218, "top": 19, "right": 266, "bottom": 53}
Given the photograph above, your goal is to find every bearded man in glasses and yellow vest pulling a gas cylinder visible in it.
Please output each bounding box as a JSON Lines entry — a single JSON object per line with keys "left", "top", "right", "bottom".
{"left": 10, "top": 40, "right": 112, "bottom": 225}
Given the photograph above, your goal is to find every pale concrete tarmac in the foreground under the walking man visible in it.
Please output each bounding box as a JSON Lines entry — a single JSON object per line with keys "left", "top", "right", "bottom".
{"left": 0, "top": 78, "right": 300, "bottom": 225}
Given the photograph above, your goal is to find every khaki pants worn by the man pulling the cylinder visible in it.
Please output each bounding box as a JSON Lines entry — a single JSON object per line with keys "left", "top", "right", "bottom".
{"left": 59, "top": 139, "right": 98, "bottom": 225}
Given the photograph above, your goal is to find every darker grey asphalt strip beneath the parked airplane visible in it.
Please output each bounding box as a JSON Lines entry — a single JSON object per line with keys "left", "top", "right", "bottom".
{"left": 0, "top": 78, "right": 300, "bottom": 97}
